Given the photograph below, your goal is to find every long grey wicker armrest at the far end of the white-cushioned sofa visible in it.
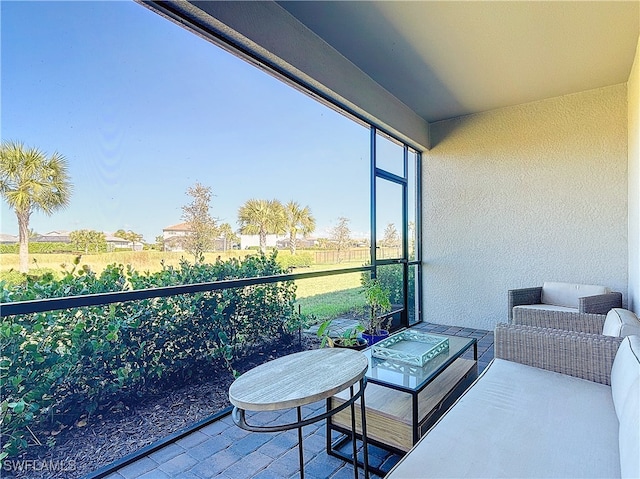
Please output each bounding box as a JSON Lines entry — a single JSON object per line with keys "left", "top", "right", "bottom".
{"left": 494, "top": 324, "right": 623, "bottom": 385}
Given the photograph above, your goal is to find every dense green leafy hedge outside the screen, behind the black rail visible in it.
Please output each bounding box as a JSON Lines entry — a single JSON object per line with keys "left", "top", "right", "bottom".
{"left": 0, "top": 253, "right": 296, "bottom": 459}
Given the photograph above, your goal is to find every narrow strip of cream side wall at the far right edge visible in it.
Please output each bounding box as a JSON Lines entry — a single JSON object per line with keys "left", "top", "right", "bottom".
{"left": 627, "top": 37, "right": 640, "bottom": 314}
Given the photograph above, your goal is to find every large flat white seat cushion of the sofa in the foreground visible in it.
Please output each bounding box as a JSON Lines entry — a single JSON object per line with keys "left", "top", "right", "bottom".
{"left": 387, "top": 359, "right": 620, "bottom": 479}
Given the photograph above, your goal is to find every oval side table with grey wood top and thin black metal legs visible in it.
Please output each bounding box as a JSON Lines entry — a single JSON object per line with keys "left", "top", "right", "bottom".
{"left": 229, "top": 348, "right": 369, "bottom": 479}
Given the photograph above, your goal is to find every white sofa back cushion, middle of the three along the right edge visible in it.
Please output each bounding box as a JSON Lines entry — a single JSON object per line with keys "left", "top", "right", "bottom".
{"left": 611, "top": 336, "right": 640, "bottom": 419}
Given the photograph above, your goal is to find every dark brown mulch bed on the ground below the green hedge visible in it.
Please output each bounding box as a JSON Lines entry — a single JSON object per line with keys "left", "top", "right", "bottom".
{"left": 8, "top": 337, "right": 318, "bottom": 479}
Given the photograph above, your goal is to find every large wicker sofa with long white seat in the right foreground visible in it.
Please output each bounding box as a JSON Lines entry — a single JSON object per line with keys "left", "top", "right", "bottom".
{"left": 386, "top": 324, "right": 640, "bottom": 479}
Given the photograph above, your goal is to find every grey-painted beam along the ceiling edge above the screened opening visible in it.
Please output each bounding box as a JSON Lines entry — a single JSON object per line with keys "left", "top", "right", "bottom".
{"left": 137, "top": 0, "right": 429, "bottom": 150}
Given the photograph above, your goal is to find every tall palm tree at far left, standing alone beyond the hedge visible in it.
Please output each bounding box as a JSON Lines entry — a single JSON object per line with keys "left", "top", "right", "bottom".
{"left": 0, "top": 141, "right": 73, "bottom": 273}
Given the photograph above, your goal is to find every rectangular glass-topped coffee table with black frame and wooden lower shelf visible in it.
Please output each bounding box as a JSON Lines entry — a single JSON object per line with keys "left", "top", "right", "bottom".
{"left": 327, "top": 335, "right": 478, "bottom": 459}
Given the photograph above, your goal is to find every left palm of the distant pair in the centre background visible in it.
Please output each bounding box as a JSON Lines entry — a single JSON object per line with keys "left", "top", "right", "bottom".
{"left": 238, "top": 199, "right": 286, "bottom": 252}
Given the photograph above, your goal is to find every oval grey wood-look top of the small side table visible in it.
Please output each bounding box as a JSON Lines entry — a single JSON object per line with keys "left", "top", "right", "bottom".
{"left": 229, "top": 348, "right": 369, "bottom": 411}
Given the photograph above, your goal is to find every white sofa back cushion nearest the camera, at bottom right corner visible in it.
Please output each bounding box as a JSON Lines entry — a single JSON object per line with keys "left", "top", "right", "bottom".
{"left": 619, "top": 378, "right": 640, "bottom": 478}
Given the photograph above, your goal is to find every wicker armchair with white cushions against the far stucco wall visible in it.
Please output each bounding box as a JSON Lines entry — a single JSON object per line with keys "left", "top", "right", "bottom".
{"left": 508, "top": 282, "right": 622, "bottom": 324}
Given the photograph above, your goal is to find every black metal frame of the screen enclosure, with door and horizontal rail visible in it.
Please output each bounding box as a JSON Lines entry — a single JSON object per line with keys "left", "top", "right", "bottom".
{"left": 0, "top": 0, "right": 422, "bottom": 477}
